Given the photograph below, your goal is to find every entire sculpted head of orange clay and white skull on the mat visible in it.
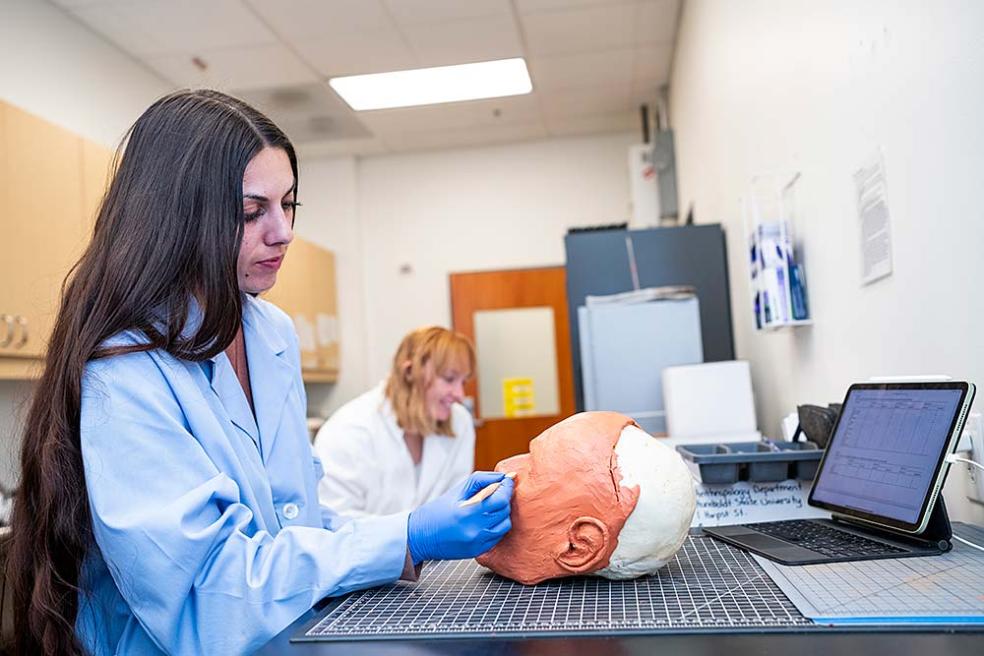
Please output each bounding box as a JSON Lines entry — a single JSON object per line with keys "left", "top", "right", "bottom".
{"left": 478, "top": 412, "right": 696, "bottom": 584}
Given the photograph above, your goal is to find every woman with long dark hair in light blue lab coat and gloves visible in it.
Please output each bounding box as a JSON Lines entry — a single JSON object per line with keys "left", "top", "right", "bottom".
{"left": 7, "top": 91, "right": 512, "bottom": 654}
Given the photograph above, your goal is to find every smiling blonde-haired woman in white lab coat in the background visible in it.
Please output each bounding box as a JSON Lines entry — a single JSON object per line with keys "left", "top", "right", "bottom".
{"left": 314, "top": 326, "right": 475, "bottom": 517}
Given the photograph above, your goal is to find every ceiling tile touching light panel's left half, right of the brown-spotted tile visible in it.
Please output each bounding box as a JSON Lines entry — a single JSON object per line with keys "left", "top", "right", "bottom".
{"left": 293, "top": 27, "right": 417, "bottom": 77}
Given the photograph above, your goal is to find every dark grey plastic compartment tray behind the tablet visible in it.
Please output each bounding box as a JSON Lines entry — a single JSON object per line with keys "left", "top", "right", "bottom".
{"left": 677, "top": 440, "right": 823, "bottom": 483}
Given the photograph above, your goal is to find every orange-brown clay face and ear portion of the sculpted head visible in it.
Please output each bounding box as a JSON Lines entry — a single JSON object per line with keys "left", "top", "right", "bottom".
{"left": 478, "top": 412, "right": 639, "bottom": 584}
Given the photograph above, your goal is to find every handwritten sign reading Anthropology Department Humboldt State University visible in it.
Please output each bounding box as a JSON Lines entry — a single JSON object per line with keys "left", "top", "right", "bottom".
{"left": 690, "top": 480, "right": 830, "bottom": 526}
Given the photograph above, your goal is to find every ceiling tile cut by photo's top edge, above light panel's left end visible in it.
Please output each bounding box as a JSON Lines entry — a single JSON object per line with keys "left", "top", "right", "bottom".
{"left": 245, "top": 0, "right": 393, "bottom": 40}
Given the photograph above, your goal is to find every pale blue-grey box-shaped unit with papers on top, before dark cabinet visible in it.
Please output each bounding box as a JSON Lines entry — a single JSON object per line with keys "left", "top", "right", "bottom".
{"left": 578, "top": 296, "right": 704, "bottom": 434}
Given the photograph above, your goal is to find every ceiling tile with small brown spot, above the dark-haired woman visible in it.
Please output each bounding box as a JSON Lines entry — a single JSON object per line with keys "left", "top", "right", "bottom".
{"left": 147, "top": 44, "right": 318, "bottom": 89}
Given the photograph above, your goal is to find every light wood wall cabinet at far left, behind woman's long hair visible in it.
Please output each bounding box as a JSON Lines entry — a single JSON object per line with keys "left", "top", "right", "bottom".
{"left": 0, "top": 103, "right": 110, "bottom": 378}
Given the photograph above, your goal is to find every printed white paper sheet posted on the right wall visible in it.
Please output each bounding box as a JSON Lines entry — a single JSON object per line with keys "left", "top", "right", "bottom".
{"left": 854, "top": 152, "right": 892, "bottom": 285}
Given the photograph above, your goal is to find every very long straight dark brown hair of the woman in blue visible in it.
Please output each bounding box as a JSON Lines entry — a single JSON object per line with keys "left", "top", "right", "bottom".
{"left": 7, "top": 91, "right": 297, "bottom": 654}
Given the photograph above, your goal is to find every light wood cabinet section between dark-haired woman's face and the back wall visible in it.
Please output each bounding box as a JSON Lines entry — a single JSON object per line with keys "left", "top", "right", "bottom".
{"left": 263, "top": 238, "right": 339, "bottom": 383}
